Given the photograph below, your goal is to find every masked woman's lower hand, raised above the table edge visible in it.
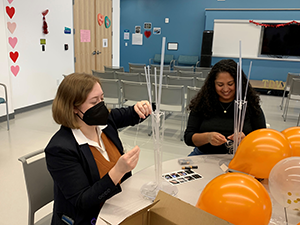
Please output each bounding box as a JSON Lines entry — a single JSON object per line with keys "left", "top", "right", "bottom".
{"left": 108, "top": 146, "right": 140, "bottom": 185}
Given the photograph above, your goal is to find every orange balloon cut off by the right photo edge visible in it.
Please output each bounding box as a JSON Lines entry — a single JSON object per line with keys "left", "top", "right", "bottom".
{"left": 281, "top": 127, "right": 300, "bottom": 156}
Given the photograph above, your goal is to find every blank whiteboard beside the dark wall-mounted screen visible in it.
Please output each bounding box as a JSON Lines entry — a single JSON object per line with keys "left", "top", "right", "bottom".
{"left": 212, "top": 20, "right": 261, "bottom": 58}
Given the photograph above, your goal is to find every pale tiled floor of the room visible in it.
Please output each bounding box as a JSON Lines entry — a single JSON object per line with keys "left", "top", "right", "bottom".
{"left": 0, "top": 95, "right": 300, "bottom": 225}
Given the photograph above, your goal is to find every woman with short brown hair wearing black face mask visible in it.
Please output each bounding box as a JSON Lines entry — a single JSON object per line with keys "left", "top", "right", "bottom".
{"left": 45, "top": 73, "right": 151, "bottom": 225}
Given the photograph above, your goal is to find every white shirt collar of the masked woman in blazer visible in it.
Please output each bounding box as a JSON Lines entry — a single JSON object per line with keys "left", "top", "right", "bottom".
{"left": 72, "top": 125, "right": 110, "bottom": 161}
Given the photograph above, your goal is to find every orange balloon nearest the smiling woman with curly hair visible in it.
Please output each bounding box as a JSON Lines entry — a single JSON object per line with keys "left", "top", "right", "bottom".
{"left": 228, "top": 128, "right": 292, "bottom": 178}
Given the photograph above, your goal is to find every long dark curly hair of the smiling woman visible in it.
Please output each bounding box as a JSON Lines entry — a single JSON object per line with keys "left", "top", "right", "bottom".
{"left": 188, "top": 59, "right": 260, "bottom": 118}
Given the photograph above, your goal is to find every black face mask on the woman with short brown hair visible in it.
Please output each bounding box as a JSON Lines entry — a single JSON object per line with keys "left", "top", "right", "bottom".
{"left": 77, "top": 102, "right": 109, "bottom": 126}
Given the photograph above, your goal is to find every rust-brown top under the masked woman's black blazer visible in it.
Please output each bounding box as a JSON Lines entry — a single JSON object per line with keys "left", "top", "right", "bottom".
{"left": 89, "top": 132, "right": 121, "bottom": 178}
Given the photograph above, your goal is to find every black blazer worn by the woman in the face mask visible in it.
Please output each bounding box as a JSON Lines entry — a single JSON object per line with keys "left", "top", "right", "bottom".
{"left": 45, "top": 107, "right": 140, "bottom": 225}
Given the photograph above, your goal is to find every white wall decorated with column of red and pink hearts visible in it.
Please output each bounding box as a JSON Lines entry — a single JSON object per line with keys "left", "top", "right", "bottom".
{"left": 0, "top": 0, "right": 120, "bottom": 116}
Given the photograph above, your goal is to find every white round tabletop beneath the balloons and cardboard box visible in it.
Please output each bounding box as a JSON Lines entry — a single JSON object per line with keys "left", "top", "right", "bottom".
{"left": 96, "top": 155, "right": 300, "bottom": 225}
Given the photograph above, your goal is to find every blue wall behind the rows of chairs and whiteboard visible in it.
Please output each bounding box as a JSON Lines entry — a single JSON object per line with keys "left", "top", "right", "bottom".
{"left": 120, "top": 0, "right": 300, "bottom": 80}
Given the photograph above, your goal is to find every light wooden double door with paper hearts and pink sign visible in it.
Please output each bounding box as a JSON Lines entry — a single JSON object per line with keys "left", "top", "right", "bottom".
{"left": 73, "top": 0, "right": 112, "bottom": 74}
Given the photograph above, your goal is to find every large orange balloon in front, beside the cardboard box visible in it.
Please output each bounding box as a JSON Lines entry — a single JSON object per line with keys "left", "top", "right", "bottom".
{"left": 196, "top": 173, "right": 272, "bottom": 225}
